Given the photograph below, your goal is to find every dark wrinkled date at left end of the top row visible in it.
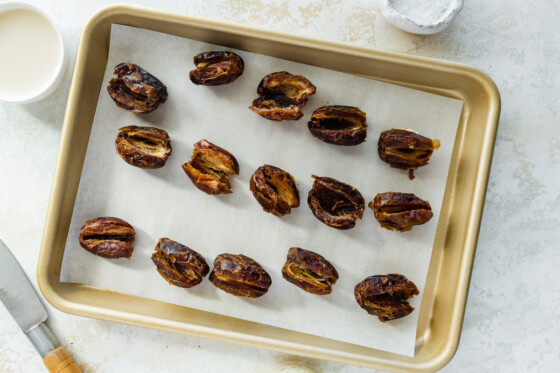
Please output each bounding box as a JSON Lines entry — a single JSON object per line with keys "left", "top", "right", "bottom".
{"left": 107, "top": 63, "right": 167, "bottom": 114}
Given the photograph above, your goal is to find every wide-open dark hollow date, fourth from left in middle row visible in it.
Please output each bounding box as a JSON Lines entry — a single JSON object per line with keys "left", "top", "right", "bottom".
{"left": 307, "top": 175, "right": 365, "bottom": 229}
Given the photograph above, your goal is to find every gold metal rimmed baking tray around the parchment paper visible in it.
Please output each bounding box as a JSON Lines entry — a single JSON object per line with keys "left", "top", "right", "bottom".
{"left": 37, "top": 5, "right": 500, "bottom": 372}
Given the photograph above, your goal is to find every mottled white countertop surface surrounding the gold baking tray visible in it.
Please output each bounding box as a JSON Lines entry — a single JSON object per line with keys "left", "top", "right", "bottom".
{"left": 0, "top": 0, "right": 560, "bottom": 373}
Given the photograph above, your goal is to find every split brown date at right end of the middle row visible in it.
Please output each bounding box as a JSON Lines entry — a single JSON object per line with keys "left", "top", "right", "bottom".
{"left": 368, "top": 192, "right": 434, "bottom": 232}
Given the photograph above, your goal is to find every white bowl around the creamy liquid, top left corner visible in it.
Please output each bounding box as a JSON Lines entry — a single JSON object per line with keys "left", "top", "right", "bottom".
{"left": 0, "top": 1, "right": 68, "bottom": 104}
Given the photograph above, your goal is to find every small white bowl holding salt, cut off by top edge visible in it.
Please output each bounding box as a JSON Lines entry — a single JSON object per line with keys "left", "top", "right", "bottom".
{"left": 381, "top": 0, "right": 463, "bottom": 35}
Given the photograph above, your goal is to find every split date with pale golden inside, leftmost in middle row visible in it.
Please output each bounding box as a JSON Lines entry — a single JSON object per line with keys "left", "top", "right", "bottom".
{"left": 115, "top": 126, "right": 171, "bottom": 168}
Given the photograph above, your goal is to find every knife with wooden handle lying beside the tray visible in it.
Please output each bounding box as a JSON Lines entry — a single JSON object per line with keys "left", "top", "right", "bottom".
{"left": 0, "top": 240, "right": 82, "bottom": 373}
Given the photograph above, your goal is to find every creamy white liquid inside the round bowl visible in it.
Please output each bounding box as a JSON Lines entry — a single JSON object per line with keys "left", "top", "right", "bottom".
{"left": 0, "top": 9, "right": 62, "bottom": 101}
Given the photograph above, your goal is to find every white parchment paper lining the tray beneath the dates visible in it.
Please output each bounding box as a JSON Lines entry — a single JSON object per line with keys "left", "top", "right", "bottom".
{"left": 61, "top": 25, "right": 463, "bottom": 356}
